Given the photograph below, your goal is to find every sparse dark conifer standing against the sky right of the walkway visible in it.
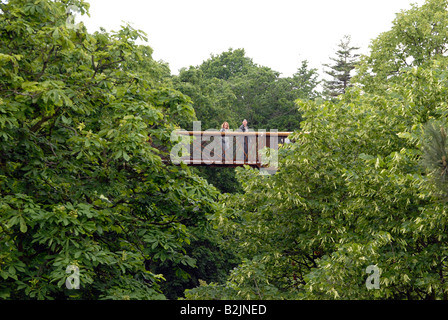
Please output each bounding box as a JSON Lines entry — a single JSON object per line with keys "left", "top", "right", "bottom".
{"left": 324, "top": 35, "right": 359, "bottom": 99}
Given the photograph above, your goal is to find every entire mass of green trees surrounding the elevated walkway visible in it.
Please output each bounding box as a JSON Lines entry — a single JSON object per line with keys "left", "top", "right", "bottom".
{"left": 0, "top": 0, "right": 448, "bottom": 300}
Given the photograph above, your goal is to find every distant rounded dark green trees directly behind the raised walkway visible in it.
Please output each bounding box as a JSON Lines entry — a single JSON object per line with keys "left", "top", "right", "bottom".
{"left": 173, "top": 49, "right": 319, "bottom": 192}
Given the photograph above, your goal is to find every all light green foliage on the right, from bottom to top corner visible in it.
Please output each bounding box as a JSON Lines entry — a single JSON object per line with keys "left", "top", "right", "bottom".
{"left": 186, "top": 0, "right": 448, "bottom": 299}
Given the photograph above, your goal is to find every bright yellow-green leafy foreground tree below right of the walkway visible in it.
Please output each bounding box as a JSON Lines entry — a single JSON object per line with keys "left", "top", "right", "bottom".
{"left": 186, "top": 70, "right": 448, "bottom": 299}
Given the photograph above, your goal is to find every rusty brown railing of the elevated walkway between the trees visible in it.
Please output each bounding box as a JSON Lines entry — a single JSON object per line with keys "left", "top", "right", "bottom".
{"left": 171, "top": 130, "right": 292, "bottom": 167}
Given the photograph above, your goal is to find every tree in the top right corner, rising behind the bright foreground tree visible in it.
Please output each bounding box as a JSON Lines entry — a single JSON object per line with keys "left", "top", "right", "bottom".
{"left": 353, "top": 0, "right": 448, "bottom": 92}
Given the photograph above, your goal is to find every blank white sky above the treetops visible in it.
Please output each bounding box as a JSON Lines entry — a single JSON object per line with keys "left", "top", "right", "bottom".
{"left": 77, "top": 0, "right": 424, "bottom": 77}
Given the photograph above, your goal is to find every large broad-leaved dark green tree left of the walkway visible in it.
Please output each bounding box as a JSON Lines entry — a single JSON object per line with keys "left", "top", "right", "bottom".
{"left": 0, "top": 0, "right": 218, "bottom": 299}
